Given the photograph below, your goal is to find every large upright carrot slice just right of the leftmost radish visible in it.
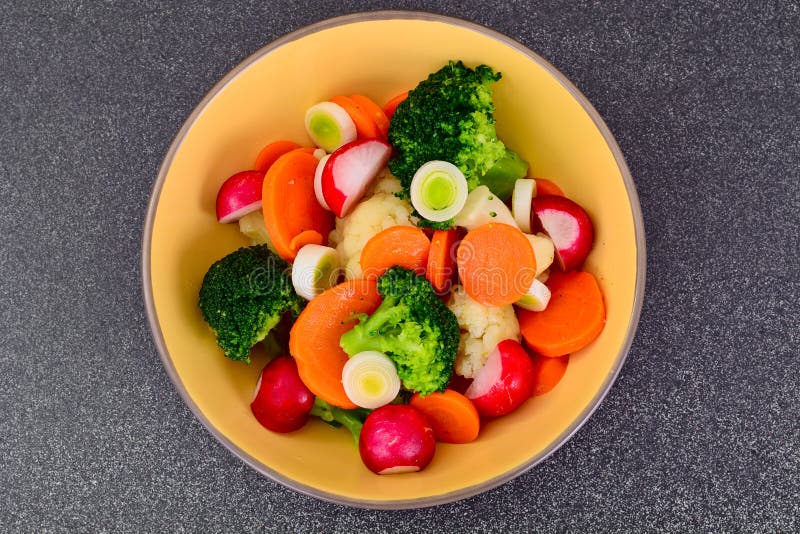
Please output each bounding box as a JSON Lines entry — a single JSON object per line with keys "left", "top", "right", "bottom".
{"left": 262, "top": 148, "right": 334, "bottom": 261}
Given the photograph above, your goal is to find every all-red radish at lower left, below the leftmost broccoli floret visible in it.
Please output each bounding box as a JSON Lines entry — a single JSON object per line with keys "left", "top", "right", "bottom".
{"left": 250, "top": 356, "right": 314, "bottom": 432}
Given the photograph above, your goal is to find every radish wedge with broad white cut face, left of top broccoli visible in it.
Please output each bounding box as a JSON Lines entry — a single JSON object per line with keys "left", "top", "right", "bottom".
{"left": 321, "top": 139, "right": 392, "bottom": 221}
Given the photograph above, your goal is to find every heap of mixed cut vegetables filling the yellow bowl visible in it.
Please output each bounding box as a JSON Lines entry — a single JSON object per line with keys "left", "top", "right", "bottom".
{"left": 199, "top": 61, "right": 605, "bottom": 474}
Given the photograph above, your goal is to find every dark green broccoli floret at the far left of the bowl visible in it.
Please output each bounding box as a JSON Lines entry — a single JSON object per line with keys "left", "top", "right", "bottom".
{"left": 200, "top": 245, "right": 305, "bottom": 363}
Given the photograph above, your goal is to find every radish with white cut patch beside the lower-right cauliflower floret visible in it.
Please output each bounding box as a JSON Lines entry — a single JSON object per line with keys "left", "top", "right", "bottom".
{"left": 464, "top": 339, "right": 534, "bottom": 417}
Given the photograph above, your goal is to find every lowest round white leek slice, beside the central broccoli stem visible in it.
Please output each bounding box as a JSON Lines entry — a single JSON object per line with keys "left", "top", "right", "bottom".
{"left": 342, "top": 350, "right": 400, "bottom": 410}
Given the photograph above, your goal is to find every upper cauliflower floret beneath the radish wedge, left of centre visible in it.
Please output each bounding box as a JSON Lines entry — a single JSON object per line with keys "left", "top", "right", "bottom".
{"left": 328, "top": 172, "right": 414, "bottom": 280}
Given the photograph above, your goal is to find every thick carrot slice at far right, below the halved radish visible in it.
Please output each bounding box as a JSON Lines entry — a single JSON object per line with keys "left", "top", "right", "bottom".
{"left": 517, "top": 271, "right": 606, "bottom": 357}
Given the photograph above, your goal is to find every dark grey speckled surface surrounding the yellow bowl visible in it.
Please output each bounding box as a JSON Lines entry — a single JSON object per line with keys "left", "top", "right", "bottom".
{"left": 0, "top": 0, "right": 800, "bottom": 532}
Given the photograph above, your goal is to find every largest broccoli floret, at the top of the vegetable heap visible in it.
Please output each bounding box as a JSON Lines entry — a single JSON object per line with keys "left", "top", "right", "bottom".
{"left": 389, "top": 61, "right": 527, "bottom": 194}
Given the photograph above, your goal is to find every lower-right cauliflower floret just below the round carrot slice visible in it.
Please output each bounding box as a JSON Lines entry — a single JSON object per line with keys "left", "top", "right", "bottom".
{"left": 447, "top": 286, "right": 520, "bottom": 378}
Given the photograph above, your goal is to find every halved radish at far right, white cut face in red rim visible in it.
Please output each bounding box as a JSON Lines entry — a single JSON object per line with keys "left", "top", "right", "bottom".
{"left": 533, "top": 195, "right": 594, "bottom": 271}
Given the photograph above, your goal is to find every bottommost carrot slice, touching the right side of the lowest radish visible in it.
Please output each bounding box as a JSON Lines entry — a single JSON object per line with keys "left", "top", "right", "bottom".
{"left": 409, "top": 389, "right": 481, "bottom": 443}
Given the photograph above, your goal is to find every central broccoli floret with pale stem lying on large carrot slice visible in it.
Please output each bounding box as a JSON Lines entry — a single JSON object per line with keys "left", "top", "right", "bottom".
{"left": 339, "top": 267, "right": 460, "bottom": 395}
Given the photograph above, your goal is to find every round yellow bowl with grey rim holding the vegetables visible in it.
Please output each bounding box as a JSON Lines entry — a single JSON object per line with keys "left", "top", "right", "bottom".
{"left": 142, "top": 12, "right": 645, "bottom": 508}
